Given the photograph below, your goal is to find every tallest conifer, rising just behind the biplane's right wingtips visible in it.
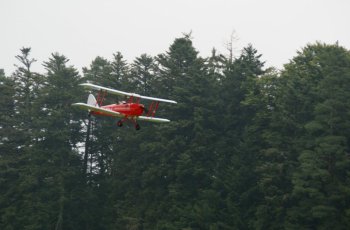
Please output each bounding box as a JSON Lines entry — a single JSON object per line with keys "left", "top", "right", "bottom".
{"left": 150, "top": 36, "right": 216, "bottom": 228}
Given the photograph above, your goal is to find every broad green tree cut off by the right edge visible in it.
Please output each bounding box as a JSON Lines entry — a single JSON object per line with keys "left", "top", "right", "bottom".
{"left": 289, "top": 43, "right": 350, "bottom": 229}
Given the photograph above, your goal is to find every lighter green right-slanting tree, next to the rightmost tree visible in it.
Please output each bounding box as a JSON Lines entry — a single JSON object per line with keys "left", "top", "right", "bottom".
{"left": 256, "top": 44, "right": 320, "bottom": 229}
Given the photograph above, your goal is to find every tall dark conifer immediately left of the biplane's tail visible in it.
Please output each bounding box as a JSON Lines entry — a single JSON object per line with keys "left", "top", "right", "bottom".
{"left": 36, "top": 53, "right": 86, "bottom": 229}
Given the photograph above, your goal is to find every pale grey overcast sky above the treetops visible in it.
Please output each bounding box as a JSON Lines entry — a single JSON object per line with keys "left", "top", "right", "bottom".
{"left": 0, "top": 0, "right": 350, "bottom": 75}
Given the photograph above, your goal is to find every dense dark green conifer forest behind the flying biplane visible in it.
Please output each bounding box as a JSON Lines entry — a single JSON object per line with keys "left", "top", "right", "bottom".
{"left": 0, "top": 35, "right": 350, "bottom": 230}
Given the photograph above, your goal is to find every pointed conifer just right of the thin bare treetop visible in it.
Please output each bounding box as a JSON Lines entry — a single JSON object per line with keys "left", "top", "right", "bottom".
{"left": 215, "top": 45, "right": 264, "bottom": 229}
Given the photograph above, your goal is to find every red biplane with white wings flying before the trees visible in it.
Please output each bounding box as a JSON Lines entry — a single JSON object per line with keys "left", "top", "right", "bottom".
{"left": 72, "top": 83, "right": 177, "bottom": 130}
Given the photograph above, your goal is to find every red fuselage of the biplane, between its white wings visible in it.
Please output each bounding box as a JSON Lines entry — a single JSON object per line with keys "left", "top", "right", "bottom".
{"left": 91, "top": 103, "right": 145, "bottom": 117}
